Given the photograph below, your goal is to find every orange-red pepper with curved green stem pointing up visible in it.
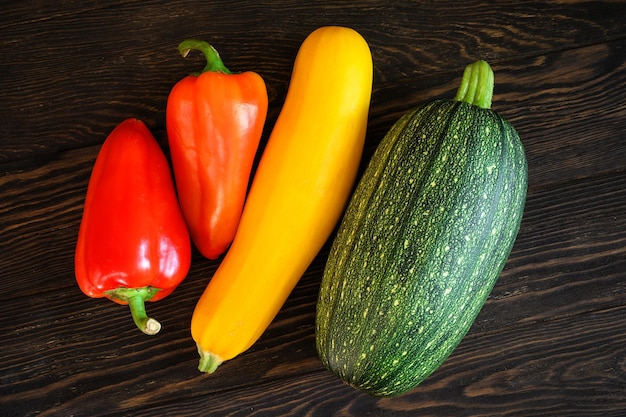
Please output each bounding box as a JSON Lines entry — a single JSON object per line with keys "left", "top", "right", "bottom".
{"left": 166, "top": 39, "right": 268, "bottom": 259}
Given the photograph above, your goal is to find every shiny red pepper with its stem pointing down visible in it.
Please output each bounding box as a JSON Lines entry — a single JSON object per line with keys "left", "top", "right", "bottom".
{"left": 74, "top": 119, "right": 191, "bottom": 334}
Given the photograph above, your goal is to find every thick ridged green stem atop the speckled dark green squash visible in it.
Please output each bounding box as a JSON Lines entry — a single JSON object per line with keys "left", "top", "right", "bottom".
{"left": 455, "top": 61, "right": 494, "bottom": 109}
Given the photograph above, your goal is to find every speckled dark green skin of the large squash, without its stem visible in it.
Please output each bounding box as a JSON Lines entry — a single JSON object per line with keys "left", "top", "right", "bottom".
{"left": 316, "top": 100, "right": 527, "bottom": 397}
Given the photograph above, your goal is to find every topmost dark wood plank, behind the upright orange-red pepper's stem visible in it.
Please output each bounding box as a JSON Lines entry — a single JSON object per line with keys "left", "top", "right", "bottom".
{"left": 0, "top": 1, "right": 626, "bottom": 164}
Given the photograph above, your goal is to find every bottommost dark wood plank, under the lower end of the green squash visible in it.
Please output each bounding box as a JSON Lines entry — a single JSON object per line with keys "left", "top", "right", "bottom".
{"left": 0, "top": 298, "right": 626, "bottom": 417}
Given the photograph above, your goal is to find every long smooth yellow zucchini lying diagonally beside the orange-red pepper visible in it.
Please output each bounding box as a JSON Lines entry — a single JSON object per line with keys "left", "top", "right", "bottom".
{"left": 191, "top": 26, "right": 373, "bottom": 373}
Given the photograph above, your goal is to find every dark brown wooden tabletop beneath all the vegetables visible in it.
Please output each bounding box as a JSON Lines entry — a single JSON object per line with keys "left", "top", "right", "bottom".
{"left": 0, "top": 0, "right": 626, "bottom": 417}
